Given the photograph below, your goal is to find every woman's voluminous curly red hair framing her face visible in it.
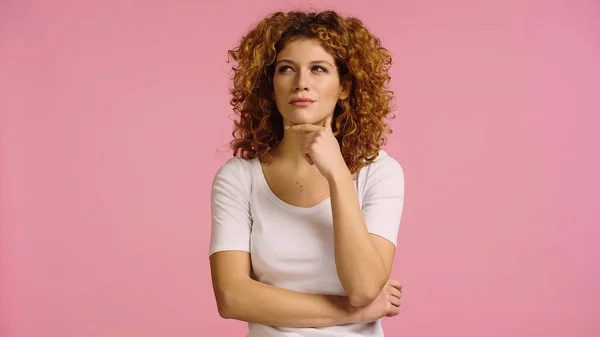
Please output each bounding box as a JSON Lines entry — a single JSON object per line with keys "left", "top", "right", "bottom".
{"left": 228, "top": 11, "right": 394, "bottom": 174}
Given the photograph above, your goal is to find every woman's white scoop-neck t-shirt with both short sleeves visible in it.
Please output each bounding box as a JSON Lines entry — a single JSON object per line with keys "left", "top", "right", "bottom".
{"left": 209, "top": 150, "right": 404, "bottom": 337}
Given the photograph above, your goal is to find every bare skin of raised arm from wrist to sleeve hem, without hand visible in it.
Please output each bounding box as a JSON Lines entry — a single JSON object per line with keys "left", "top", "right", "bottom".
{"left": 328, "top": 171, "right": 395, "bottom": 306}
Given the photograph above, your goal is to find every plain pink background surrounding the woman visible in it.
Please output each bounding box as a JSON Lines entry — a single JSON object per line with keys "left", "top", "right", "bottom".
{"left": 0, "top": 0, "right": 600, "bottom": 337}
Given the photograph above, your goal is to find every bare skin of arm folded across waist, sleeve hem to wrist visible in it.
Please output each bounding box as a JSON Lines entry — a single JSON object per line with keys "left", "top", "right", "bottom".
{"left": 210, "top": 251, "right": 359, "bottom": 328}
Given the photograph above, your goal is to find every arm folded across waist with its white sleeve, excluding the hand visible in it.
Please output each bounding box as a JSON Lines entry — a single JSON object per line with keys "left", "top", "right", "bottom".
{"left": 209, "top": 158, "right": 360, "bottom": 327}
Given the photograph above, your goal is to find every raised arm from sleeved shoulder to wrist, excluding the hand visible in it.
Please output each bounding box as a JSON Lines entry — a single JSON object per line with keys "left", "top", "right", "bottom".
{"left": 328, "top": 163, "right": 404, "bottom": 306}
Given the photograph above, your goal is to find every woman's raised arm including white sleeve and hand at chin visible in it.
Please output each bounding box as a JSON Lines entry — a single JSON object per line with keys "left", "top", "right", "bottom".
{"left": 285, "top": 121, "right": 404, "bottom": 306}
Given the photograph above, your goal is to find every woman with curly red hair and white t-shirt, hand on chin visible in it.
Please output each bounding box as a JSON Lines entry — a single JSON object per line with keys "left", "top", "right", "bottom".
{"left": 209, "top": 11, "right": 404, "bottom": 336}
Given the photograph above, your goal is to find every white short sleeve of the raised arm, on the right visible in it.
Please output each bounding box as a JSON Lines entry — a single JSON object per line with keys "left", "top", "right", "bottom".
{"left": 362, "top": 155, "right": 404, "bottom": 246}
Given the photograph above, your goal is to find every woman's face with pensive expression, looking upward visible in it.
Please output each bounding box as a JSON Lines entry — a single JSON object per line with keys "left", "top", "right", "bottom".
{"left": 273, "top": 39, "right": 347, "bottom": 125}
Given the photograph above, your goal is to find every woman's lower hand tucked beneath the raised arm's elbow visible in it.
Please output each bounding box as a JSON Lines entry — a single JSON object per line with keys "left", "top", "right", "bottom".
{"left": 353, "top": 279, "right": 402, "bottom": 323}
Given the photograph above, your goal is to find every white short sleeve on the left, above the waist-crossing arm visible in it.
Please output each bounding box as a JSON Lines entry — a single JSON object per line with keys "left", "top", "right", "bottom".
{"left": 209, "top": 157, "right": 252, "bottom": 256}
